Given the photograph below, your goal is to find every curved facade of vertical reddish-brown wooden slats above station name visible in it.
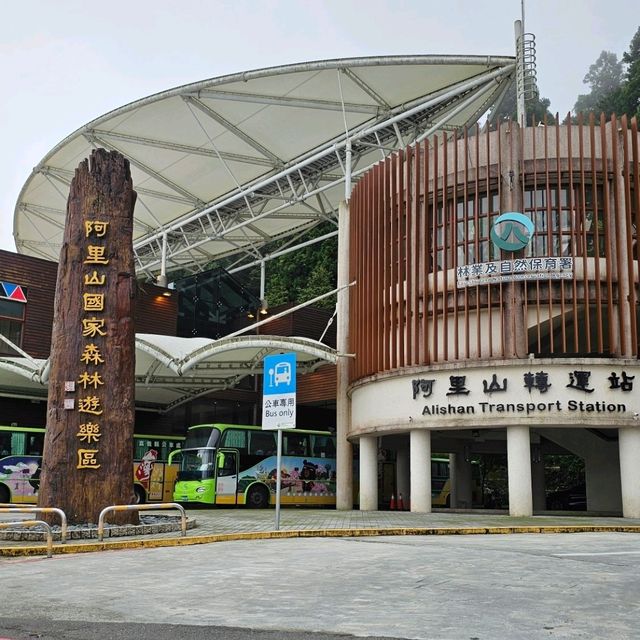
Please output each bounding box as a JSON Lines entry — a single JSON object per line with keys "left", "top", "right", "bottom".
{"left": 349, "top": 117, "right": 640, "bottom": 382}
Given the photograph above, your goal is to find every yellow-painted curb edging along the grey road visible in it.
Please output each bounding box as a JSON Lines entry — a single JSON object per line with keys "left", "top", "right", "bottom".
{"left": 0, "top": 525, "right": 640, "bottom": 557}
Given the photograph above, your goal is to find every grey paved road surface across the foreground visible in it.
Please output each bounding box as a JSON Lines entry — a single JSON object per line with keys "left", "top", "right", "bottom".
{"left": 0, "top": 533, "right": 640, "bottom": 640}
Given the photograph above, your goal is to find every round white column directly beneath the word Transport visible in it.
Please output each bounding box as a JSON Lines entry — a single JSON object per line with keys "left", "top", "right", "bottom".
{"left": 507, "top": 426, "right": 533, "bottom": 516}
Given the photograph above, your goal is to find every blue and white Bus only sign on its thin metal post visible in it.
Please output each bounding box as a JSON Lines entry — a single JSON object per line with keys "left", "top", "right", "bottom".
{"left": 262, "top": 353, "right": 296, "bottom": 531}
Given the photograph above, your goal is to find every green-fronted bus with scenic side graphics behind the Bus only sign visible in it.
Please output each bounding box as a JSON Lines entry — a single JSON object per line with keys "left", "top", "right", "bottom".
{"left": 173, "top": 424, "right": 336, "bottom": 509}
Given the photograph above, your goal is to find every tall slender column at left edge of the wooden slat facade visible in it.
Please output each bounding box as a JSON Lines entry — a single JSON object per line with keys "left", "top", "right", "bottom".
{"left": 336, "top": 201, "right": 356, "bottom": 511}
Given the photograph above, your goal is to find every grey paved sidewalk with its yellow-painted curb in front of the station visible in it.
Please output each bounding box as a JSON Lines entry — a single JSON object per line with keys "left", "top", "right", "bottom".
{"left": 0, "top": 508, "right": 640, "bottom": 557}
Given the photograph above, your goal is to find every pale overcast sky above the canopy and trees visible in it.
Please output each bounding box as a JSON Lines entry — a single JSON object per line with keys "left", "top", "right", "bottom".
{"left": 0, "top": 0, "right": 640, "bottom": 251}
